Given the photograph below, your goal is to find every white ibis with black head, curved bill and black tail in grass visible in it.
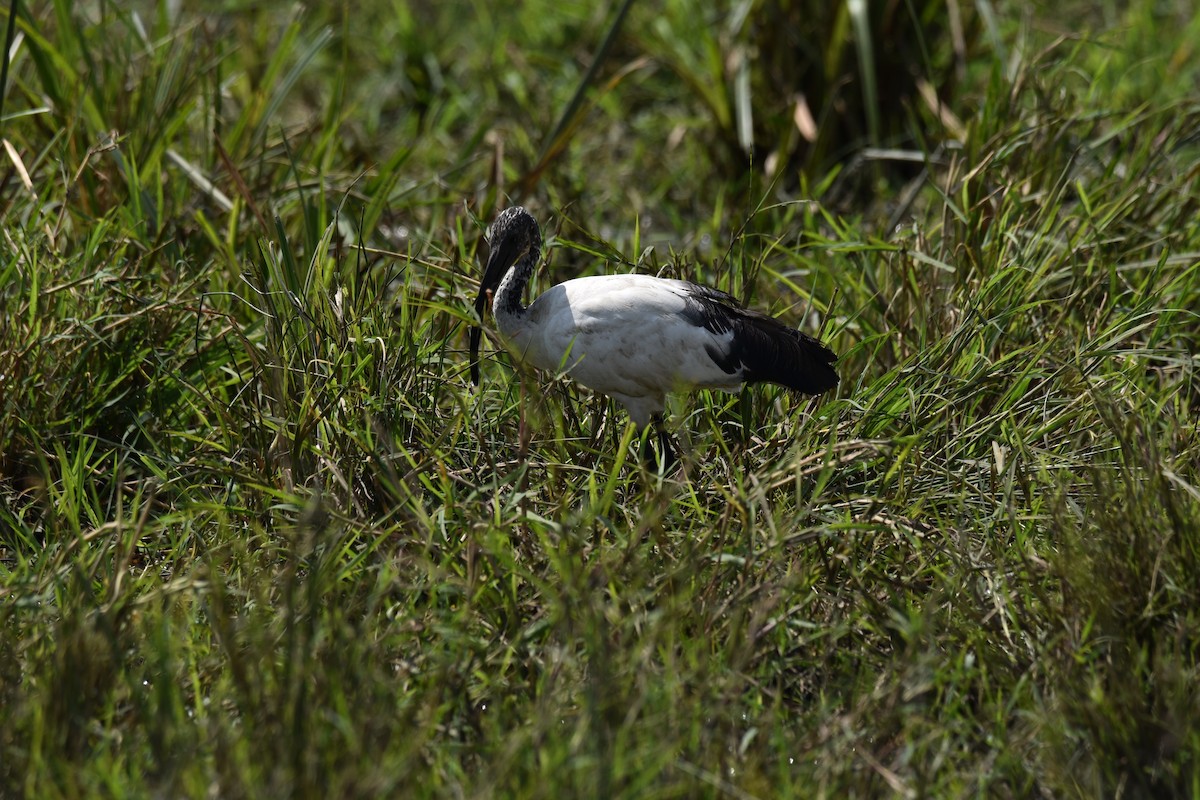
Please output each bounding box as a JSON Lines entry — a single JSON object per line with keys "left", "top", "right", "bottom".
{"left": 470, "top": 206, "right": 839, "bottom": 469}
